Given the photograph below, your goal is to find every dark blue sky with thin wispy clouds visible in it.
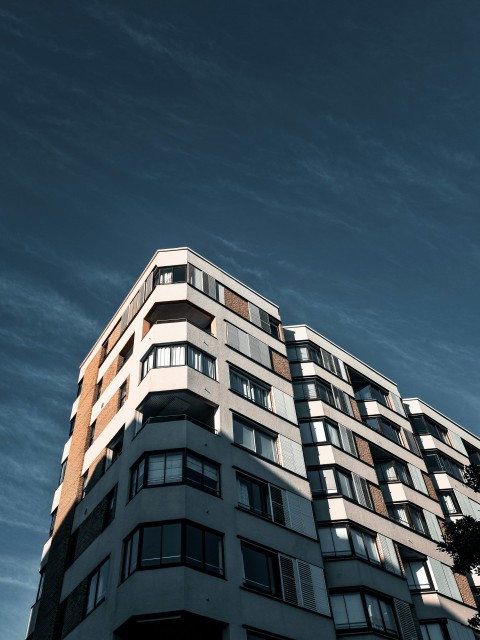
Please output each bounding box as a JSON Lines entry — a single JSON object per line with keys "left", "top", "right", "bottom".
{"left": 0, "top": 0, "right": 480, "bottom": 640}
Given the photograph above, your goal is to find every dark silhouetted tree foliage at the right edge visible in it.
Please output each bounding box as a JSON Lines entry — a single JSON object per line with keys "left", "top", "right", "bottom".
{"left": 439, "top": 464, "right": 480, "bottom": 629}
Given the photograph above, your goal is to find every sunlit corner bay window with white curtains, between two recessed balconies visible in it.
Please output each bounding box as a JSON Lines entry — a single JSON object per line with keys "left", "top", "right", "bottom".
{"left": 142, "top": 344, "right": 216, "bottom": 380}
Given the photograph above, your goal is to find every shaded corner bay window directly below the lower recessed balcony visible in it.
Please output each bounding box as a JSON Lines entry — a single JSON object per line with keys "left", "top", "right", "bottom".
{"left": 130, "top": 450, "right": 220, "bottom": 498}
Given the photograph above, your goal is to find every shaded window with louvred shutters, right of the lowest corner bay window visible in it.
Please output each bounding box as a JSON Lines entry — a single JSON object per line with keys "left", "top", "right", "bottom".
{"left": 242, "top": 542, "right": 330, "bottom": 615}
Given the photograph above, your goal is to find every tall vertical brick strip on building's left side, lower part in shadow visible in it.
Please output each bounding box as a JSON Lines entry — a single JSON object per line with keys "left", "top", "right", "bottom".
{"left": 31, "top": 349, "right": 103, "bottom": 640}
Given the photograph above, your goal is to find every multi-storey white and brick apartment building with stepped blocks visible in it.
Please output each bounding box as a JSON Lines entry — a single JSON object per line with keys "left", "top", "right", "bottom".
{"left": 27, "top": 248, "right": 480, "bottom": 640}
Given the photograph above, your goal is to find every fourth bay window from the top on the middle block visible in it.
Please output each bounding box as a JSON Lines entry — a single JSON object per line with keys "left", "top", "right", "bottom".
{"left": 308, "top": 468, "right": 373, "bottom": 510}
